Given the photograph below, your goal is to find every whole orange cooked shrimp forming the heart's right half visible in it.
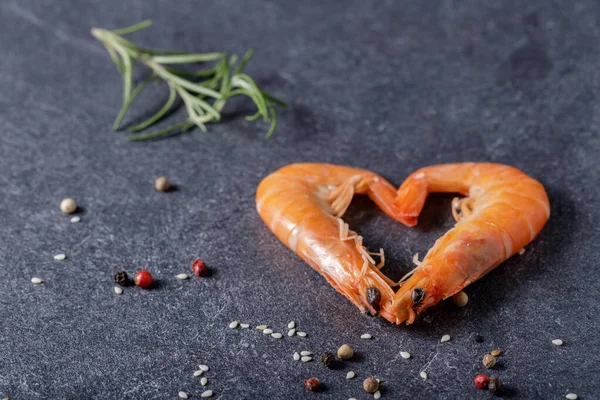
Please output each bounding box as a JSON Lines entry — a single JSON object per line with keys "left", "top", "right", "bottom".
{"left": 392, "top": 163, "right": 550, "bottom": 323}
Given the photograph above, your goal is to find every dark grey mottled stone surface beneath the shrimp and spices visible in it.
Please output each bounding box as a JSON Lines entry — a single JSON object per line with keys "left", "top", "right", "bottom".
{"left": 0, "top": 0, "right": 600, "bottom": 400}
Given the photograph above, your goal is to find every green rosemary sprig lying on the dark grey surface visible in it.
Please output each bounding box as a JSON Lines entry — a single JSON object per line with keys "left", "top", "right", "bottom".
{"left": 92, "top": 21, "right": 287, "bottom": 140}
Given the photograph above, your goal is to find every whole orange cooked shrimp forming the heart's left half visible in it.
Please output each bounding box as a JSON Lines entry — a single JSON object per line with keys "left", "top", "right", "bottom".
{"left": 256, "top": 163, "right": 400, "bottom": 320}
